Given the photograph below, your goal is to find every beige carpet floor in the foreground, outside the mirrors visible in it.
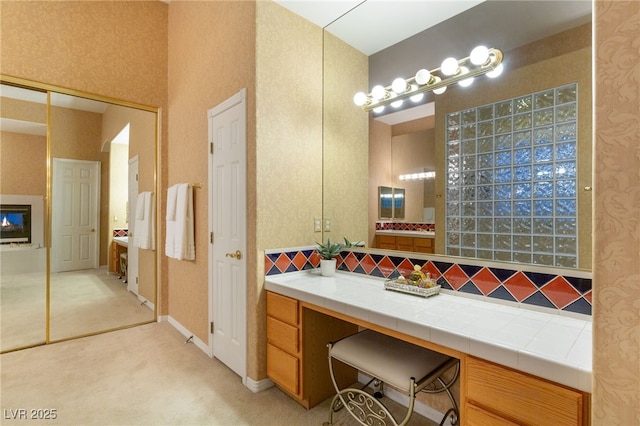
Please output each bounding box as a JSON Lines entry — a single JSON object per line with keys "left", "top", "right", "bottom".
{"left": 0, "top": 323, "right": 435, "bottom": 426}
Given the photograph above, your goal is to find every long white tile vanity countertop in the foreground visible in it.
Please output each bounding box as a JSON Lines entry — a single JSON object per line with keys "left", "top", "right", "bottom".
{"left": 265, "top": 270, "right": 592, "bottom": 393}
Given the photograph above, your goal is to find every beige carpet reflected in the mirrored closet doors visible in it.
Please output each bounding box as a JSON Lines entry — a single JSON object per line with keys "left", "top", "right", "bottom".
{"left": 0, "top": 268, "right": 154, "bottom": 351}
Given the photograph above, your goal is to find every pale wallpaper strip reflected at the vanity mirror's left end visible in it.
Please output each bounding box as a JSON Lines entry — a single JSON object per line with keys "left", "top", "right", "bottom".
{"left": 324, "top": 32, "right": 369, "bottom": 242}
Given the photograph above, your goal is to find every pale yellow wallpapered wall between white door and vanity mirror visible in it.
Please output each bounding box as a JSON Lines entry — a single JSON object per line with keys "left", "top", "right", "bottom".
{"left": 255, "top": 1, "right": 322, "bottom": 380}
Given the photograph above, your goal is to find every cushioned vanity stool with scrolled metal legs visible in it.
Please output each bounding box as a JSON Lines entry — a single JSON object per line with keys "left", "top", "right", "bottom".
{"left": 324, "top": 330, "right": 460, "bottom": 426}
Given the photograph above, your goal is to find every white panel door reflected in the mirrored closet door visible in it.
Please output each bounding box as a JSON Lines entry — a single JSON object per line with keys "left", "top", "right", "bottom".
{"left": 51, "top": 158, "right": 100, "bottom": 272}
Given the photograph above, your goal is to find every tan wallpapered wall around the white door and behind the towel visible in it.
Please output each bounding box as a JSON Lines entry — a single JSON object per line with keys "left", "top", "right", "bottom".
{"left": 168, "top": 1, "right": 255, "bottom": 343}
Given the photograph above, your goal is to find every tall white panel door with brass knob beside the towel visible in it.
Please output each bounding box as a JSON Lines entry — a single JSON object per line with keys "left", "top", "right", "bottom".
{"left": 208, "top": 89, "right": 247, "bottom": 383}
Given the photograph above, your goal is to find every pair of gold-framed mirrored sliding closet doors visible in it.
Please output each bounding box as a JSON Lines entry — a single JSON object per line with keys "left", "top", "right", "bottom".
{"left": 0, "top": 78, "right": 157, "bottom": 351}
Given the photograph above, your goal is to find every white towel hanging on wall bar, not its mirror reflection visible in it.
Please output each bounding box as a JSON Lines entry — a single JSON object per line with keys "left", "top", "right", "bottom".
{"left": 165, "top": 183, "right": 196, "bottom": 260}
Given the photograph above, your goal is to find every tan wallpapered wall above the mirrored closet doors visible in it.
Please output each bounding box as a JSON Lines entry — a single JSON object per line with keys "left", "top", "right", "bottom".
{"left": 0, "top": 1, "right": 168, "bottom": 313}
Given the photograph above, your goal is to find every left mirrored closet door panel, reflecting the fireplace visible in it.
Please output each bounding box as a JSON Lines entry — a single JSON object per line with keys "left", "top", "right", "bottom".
{"left": 0, "top": 84, "right": 47, "bottom": 351}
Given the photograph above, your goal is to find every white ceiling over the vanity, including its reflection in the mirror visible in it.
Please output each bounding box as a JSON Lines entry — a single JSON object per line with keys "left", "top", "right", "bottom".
{"left": 274, "top": 0, "right": 592, "bottom": 56}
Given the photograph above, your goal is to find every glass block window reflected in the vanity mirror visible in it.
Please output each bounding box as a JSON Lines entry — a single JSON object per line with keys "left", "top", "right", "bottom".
{"left": 445, "top": 83, "right": 578, "bottom": 268}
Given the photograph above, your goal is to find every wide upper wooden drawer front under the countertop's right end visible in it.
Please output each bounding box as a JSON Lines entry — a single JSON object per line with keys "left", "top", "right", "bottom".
{"left": 467, "top": 357, "right": 583, "bottom": 426}
